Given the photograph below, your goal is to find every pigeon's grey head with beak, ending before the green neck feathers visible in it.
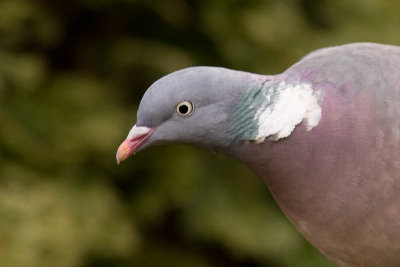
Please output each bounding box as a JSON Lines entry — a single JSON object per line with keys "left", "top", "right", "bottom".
{"left": 117, "top": 67, "right": 265, "bottom": 162}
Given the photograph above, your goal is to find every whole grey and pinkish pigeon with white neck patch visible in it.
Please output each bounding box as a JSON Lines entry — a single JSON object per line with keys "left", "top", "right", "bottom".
{"left": 117, "top": 43, "right": 400, "bottom": 266}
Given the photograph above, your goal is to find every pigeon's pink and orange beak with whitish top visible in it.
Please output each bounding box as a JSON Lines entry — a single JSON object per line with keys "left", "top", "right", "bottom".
{"left": 116, "top": 125, "right": 154, "bottom": 164}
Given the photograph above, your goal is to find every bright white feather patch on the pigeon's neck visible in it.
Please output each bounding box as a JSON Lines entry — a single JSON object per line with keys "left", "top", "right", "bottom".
{"left": 255, "top": 82, "right": 321, "bottom": 143}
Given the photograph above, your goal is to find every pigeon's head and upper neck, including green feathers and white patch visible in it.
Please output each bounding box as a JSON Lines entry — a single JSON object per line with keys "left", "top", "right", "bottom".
{"left": 117, "top": 67, "right": 321, "bottom": 162}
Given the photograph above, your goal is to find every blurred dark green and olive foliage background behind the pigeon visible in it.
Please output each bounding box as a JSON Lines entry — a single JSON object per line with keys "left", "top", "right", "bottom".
{"left": 0, "top": 0, "right": 400, "bottom": 267}
